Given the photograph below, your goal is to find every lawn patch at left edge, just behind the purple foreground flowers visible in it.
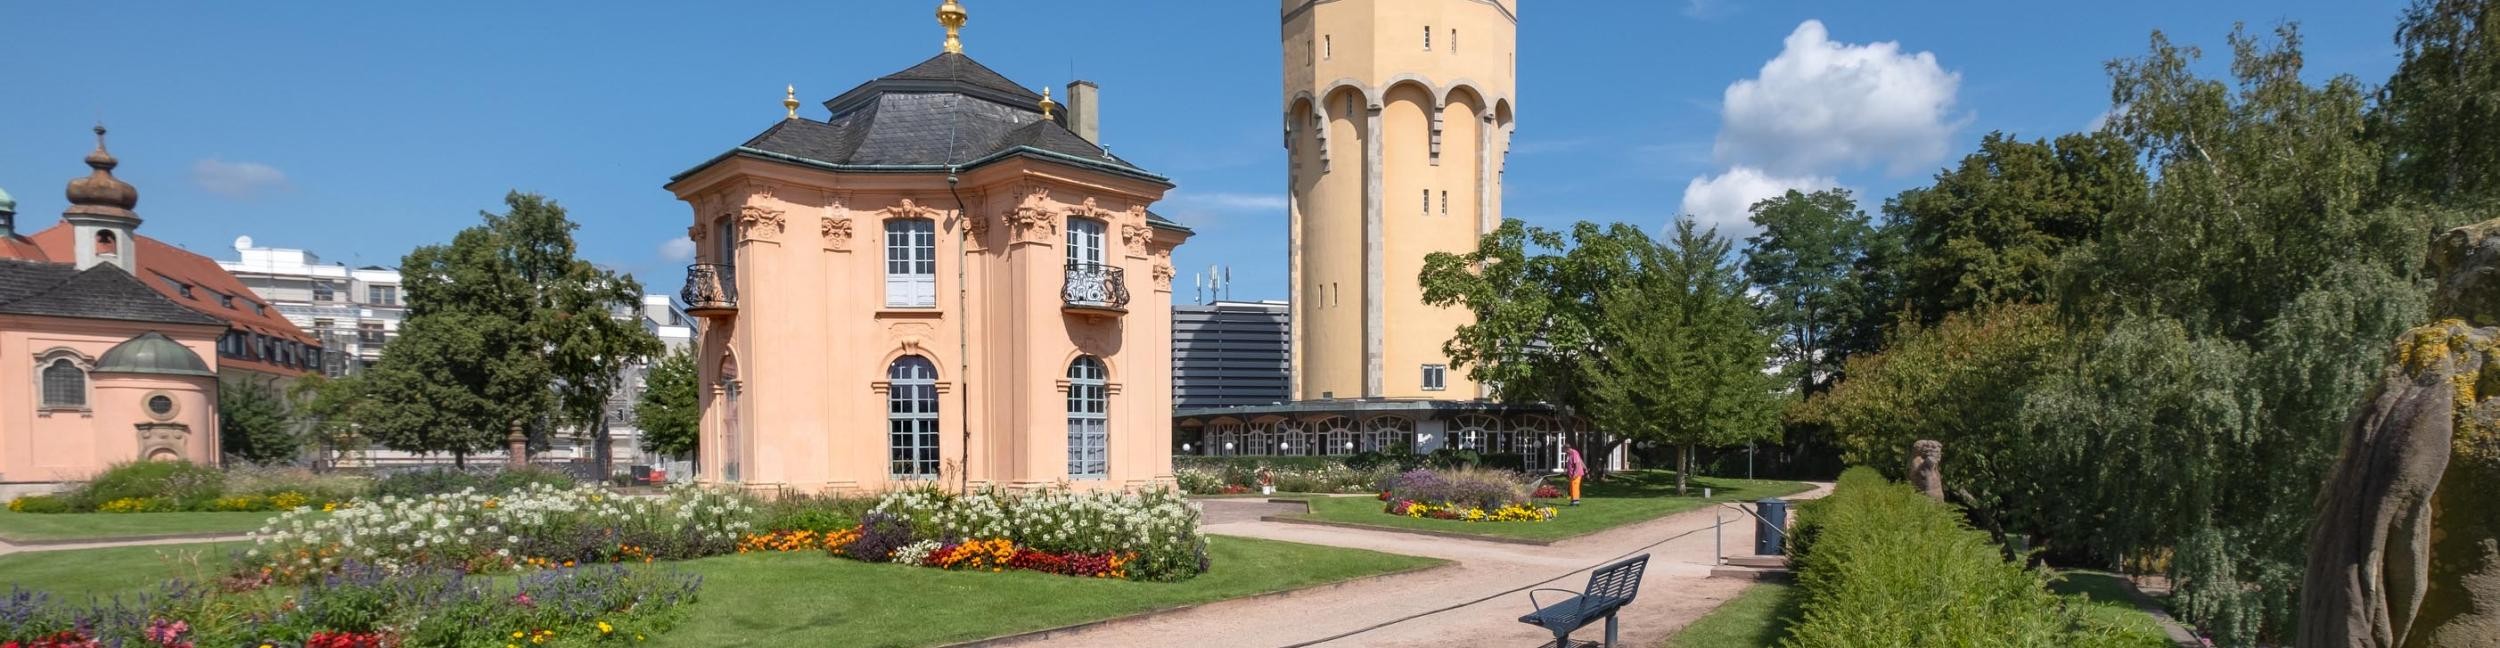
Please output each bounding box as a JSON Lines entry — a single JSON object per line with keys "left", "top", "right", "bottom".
{"left": 0, "top": 540, "right": 253, "bottom": 598}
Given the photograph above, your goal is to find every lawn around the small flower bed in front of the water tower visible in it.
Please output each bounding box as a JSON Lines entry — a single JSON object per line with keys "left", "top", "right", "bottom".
{"left": 1303, "top": 470, "right": 1813, "bottom": 540}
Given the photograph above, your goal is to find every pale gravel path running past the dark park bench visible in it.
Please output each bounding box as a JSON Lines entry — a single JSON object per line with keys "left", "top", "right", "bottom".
{"left": 995, "top": 483, "right": 1830, "bottom": 648}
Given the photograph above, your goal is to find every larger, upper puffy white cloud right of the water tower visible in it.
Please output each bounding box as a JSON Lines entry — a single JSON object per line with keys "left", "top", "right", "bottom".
{"left": 1713, "top": 20, "right": 1970, "bottom": 175}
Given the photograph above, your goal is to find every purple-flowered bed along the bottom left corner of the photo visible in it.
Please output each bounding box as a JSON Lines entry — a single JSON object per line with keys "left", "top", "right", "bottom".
{"left": 0, "top": 563, "right": 703, "bottom": 648}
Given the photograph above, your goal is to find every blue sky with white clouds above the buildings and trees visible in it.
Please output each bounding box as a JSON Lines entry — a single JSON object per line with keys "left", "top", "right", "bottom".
{"left": 0, "top": 0, "right": 2403, "bottom": 300}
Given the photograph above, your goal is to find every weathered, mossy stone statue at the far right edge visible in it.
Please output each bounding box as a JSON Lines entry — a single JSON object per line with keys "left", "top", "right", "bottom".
{"left": 2298, "top": 220, "right": 2500, "bottom": 648}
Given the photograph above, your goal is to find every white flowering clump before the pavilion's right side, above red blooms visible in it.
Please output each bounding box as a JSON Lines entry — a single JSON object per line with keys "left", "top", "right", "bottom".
{"left": 873, "top": 488, "right": 1208, "bottom": 580}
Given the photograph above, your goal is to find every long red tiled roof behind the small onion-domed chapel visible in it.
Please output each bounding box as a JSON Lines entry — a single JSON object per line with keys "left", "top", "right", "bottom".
{"left": 30, "top": 223, "right": 320, "bottom": 375}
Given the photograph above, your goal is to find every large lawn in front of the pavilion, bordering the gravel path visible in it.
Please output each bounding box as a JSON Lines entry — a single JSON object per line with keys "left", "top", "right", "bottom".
{"left": 650, "top": 535, "right": 1443, "bottom": 645}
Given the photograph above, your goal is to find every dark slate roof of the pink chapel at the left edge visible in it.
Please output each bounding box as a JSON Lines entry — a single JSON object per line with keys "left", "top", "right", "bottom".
{"left": 0, "top": 258, "right": 225, "bottom": 325}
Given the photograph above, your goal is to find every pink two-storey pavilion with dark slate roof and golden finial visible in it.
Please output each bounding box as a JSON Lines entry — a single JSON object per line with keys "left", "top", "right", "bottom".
{"left": 668, "top": 0, "right": 1190, "bottom": 490}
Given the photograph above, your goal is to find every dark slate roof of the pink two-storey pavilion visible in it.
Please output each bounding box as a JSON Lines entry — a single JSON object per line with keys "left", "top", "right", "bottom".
{"left": 670, "top": 53, "right": 1180, "bottom": 228}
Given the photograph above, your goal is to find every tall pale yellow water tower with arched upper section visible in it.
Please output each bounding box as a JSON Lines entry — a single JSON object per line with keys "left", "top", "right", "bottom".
{"left": 1283, "top": 0, "right": 1520, "bottom": 400}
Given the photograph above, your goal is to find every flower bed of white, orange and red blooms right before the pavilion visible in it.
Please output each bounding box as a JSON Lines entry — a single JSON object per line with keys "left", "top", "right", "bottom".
{"left": 738, "top": 488, "right": 1208, "bottom": 580}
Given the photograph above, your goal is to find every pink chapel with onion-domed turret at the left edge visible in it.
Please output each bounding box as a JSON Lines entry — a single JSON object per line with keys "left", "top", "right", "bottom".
{"left": 0, "top": 125, "right": 232, "bottom": 495}
